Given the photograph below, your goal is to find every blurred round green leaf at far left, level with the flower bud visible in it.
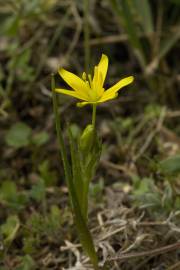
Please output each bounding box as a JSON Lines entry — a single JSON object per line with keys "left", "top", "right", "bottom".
{"left": 5, "top": 122, "right": 32, "bottom": 148}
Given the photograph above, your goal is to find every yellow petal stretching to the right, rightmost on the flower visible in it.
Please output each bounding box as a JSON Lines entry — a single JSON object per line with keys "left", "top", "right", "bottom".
{"left": 102, "top": 76, "right": 134, "bottom": 99}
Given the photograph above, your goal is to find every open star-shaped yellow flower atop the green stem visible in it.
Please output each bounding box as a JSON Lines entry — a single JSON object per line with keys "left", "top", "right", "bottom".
{"left": 55, "top": 54, "right": 134, "bottom": 106}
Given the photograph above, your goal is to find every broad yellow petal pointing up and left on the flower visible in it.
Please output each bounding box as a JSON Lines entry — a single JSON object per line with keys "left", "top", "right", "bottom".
{"left": 59, "top": 68, "right": 89, "bottom": 99}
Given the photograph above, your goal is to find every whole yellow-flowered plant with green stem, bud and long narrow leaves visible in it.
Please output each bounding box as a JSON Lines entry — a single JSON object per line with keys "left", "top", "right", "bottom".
{"left": 51, "top": 54, "right": 133, "bottom": 269}
